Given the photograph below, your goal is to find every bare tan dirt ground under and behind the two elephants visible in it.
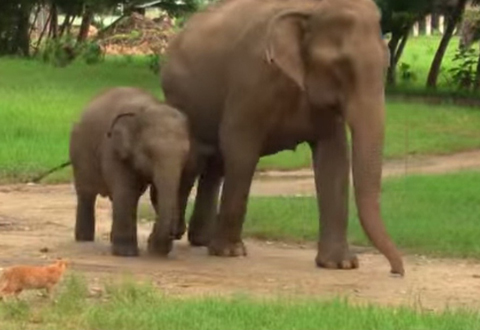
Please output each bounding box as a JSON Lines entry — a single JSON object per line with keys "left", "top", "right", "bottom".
{"left": 0, "top": 150, "right": 480, "bottom": 309}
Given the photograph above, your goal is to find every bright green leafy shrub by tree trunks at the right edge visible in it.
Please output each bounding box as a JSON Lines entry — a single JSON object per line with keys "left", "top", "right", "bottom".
{"left": 448, "top": 48, "right": 478, "bottom": 90}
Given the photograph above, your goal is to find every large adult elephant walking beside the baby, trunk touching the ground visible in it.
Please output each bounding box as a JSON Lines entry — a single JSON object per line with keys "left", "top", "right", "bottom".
{"left": 161, "top": 0, "right": 404, "bottom": 274}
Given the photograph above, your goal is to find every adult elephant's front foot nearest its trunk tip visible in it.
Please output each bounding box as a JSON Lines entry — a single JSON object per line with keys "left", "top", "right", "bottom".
{"left": 315, "top": 243, "right": 359, "bottom": 269}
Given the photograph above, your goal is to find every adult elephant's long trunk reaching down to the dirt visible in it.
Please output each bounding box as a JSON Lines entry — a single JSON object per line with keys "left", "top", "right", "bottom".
{"left": 347, "top": 93, "right": 405, "bottom": 275}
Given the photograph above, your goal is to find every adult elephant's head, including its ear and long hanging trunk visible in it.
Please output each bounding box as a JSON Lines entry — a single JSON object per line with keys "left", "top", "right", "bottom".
{"left": 265, "top": 0, "right": 404, "bottom": 274}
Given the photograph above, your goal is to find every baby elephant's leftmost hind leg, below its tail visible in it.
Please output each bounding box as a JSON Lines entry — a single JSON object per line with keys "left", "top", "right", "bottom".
{"left": 75, "top": 191, "right": 97, "bottom": 242}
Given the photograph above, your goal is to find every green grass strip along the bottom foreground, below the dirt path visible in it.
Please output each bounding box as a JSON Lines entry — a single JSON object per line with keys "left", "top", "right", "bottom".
{"left": 0, "top": 276, "right": 480, "bottom": 330}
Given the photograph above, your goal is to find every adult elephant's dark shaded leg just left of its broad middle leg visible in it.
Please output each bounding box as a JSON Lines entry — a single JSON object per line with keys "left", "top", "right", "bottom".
{"left": 188, "top": 156, "right": 223, "bottom": 246}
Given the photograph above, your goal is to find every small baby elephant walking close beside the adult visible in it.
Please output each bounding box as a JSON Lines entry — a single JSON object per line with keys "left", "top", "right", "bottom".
{"left": 70, "top": 87, "right": 190, "bottom": 256}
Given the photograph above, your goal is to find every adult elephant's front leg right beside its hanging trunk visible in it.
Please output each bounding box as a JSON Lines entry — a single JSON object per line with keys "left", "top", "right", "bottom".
{"left": 311, "top": 119, "right": 358, "bottom": 269}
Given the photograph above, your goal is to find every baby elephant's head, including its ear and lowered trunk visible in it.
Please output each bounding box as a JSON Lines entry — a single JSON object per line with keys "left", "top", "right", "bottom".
{"left": 107, "top": 105, "right": 190, "bottom": 254}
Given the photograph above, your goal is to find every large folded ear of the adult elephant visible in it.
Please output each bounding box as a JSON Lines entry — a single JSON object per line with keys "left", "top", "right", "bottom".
{"left": 266, "top": 11, "right": 310, "bottom": 90}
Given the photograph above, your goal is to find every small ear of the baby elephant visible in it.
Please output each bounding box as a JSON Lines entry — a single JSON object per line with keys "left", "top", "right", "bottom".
{"left": 107, "top": 113, "right": 135, "bottom": 160}
